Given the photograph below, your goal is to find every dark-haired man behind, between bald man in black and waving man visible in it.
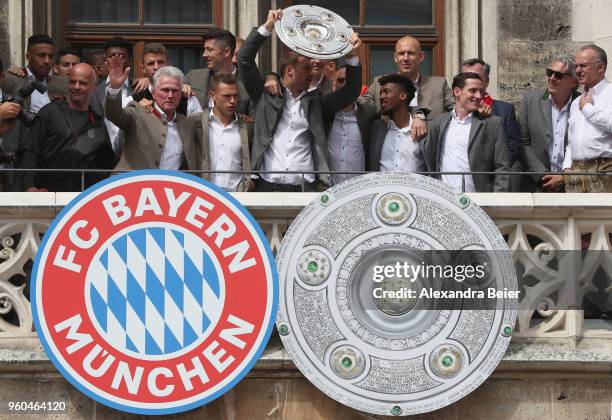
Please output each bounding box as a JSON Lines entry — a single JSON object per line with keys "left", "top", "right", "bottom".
{"left": 91, "top": 37, "right": 133, "bottom": 155}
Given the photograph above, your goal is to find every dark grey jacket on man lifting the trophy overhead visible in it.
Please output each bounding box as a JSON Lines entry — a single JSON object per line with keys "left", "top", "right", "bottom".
{"left": 238, "top": 29, "right": 361, "bottom": 185}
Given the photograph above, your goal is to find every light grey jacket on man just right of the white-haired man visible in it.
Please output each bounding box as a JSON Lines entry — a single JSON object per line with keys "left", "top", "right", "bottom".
{"left": 187, "top": 110, "right": 253, "bottom": 191}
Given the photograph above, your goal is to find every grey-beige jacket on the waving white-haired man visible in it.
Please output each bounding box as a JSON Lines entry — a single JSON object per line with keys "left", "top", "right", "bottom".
{"left": 105, "top": 95, "right": 201, "bottom": 170}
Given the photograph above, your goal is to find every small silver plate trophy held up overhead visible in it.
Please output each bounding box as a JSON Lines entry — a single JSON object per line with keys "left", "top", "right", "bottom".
{"left": 275, "top": 5, "right": 353, "bottom": 59}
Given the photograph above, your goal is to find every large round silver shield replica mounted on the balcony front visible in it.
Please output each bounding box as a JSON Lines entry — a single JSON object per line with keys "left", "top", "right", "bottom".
{"left": 277, "top": 172, "right": 518, "bottom": 416}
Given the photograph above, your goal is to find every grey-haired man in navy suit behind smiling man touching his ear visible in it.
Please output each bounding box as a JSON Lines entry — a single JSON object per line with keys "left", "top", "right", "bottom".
{"left": 462, "top": 58, "right": 521, "bottom": 164}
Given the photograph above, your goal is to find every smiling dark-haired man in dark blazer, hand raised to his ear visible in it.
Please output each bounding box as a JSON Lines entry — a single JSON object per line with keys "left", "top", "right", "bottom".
{"left": 423, "top": 73, "right": 509, "bottom": 193}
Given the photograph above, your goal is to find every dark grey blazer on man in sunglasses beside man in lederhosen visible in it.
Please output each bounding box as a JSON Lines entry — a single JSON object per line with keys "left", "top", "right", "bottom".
{"left": 518, "top": 90, "right": 578, "bottom": 192}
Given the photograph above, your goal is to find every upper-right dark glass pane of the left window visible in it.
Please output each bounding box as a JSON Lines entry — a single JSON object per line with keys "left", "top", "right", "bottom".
{"left": 144, "top": 0, "right": 213, "bottom": 25}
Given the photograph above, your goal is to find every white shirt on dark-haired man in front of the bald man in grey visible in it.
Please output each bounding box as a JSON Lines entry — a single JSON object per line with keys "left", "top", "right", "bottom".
{"left": 380, "top": 118, "right": 427, "bottom": 172}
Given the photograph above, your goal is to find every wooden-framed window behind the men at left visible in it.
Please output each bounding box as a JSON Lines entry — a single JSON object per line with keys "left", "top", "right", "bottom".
{"left": 57, "top": 0, "right": 223, "bottom": 76}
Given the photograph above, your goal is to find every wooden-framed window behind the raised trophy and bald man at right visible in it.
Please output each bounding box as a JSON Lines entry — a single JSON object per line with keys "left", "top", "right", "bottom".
{"left": 284, "top": 0, "right": 444, "bottom": 81}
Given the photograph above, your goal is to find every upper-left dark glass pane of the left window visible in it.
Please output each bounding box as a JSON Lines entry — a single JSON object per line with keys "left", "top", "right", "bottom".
{"left": 70, "top": 0, "right": 138, "bottom": 23}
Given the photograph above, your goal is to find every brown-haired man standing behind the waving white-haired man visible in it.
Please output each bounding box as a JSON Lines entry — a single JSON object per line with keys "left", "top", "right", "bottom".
{"left": 132, "top": 42, "right": 202, "bottom": 115}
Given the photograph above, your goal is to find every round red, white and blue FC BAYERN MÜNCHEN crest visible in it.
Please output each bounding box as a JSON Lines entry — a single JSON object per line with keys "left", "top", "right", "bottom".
{"left": 31, "top": 171, "right": 278, "bottom": 414}
